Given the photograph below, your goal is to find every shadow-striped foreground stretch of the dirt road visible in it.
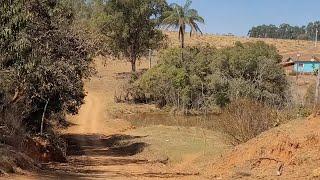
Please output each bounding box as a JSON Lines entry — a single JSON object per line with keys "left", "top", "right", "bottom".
{"left": 38, "top": 134, "right": 198, "bottom": 179}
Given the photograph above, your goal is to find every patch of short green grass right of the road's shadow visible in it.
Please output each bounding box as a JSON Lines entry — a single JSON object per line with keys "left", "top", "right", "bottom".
{"left": 129, "top": 125, "right": 231, "bottom": 164}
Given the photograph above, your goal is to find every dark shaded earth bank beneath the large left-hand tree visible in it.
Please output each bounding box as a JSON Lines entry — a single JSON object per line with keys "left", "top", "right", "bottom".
{"left": 0, "top": 136, "right": 67, "bottom": 176}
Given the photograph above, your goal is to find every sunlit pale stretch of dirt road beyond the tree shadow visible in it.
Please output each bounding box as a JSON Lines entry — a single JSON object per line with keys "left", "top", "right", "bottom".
{"left": 64, "top": 59, "right": 134, "bottom": 135}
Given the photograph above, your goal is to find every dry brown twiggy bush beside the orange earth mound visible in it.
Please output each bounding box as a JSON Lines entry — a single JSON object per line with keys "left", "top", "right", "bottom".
{"left": 218, "top": 99, "right": 279, "bottom": 145}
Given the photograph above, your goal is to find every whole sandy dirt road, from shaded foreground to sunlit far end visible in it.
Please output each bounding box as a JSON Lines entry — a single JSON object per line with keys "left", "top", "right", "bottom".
{"left": 8, "top": 59, "right": 199, "bottom": 179}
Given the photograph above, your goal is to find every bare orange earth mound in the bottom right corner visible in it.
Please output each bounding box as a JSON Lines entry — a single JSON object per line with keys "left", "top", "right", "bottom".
{"left": 207, "top": 118, "right": 320, "bottom": 179}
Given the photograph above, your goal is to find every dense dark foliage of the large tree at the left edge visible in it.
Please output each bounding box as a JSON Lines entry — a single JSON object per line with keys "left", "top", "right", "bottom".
{"left": 0, "top": 0, "right": 93, "bottom": 132}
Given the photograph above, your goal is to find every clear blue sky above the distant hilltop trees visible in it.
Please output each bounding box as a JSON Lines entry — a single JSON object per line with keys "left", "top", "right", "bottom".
{"left": 168, "top": 0, "right": 320, "bottom": 36}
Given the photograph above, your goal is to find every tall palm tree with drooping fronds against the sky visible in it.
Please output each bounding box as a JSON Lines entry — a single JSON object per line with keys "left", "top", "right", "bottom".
{"left": 162, "top": 0, "right": 204, "bottom": 48}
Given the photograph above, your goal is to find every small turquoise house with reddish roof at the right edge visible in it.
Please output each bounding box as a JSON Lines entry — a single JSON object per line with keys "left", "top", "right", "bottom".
{"left": 280, "top": 56, "right": 320, "bottom": 74}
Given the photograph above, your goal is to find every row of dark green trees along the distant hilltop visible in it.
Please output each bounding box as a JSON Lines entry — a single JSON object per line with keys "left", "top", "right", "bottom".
{"left": 248, "top": 21, "right": 320, "bottom": 40}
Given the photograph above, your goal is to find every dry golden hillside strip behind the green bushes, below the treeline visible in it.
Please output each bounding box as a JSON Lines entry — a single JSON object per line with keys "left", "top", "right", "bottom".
{"left": 165, "top": 32, "right": 320, "bottom": 58}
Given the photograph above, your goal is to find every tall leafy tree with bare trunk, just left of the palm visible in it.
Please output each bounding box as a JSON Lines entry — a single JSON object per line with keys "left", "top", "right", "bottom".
{"left": 101, "top": 0, "right": 167, "bottom": 72}
